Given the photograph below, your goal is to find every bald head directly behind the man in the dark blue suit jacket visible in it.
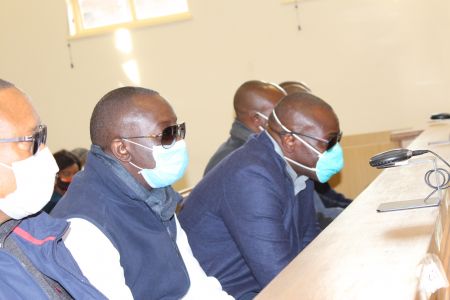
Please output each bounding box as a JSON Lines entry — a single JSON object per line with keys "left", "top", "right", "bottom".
{"left": 233, "top": 80, "right": 286, "bottom": 132}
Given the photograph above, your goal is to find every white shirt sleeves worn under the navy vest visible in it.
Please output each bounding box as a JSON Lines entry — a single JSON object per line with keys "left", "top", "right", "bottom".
{"left": 64, "top": 217, "right": 233, "bottom": 300}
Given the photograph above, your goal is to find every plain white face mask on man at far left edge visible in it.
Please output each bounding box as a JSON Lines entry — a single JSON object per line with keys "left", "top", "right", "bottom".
{"left": 0, "top": 147, "right": 58, "bottom": 220}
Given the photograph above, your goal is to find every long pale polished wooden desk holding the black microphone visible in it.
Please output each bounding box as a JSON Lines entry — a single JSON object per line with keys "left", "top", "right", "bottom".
{"left": 257, "top": 122, "right": 450, "bottom": 300}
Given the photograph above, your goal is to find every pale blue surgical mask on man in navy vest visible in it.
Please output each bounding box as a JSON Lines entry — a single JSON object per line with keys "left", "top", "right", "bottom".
{"left": 125, "top": 139, "right": 189, "bottom": 188}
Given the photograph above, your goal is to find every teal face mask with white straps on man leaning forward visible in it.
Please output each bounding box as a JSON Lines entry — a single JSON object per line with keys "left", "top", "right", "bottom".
{"left": 273, "top": 110, "right": 344, "bottom": 183}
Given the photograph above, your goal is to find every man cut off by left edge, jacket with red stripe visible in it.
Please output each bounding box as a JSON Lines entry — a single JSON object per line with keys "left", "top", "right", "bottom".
{"left": 0, "top": 79, "right": 105, "bottom": 299}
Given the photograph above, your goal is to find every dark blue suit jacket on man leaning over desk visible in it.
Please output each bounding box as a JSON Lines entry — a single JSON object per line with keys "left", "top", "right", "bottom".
{"left": 179, "top": 133, "right": 319, "bottom": 298}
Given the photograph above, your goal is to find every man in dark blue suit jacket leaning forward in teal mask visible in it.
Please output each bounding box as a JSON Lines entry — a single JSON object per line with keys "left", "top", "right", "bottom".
{"left": 179, "top": 93, "right": 343, "bottom": 299}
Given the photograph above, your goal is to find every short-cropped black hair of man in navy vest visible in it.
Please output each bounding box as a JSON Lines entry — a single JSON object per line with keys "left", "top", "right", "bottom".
{"left": 90, "top": 86, "right": 158, "bottom": 150}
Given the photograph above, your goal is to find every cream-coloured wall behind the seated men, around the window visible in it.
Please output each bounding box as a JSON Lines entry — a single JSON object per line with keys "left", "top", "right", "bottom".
{"left": 0, "top": 0, "right": 450, "bottom": 187}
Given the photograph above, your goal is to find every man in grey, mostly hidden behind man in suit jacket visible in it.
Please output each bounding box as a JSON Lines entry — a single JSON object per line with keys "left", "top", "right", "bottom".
{"left": 204, "top": 80, "right": 286, "bottom": 175}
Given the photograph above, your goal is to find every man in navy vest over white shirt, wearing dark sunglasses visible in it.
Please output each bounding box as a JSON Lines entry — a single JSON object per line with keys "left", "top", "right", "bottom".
{"left": 52, "top": 87, "right": 230, "bottom": 299}
